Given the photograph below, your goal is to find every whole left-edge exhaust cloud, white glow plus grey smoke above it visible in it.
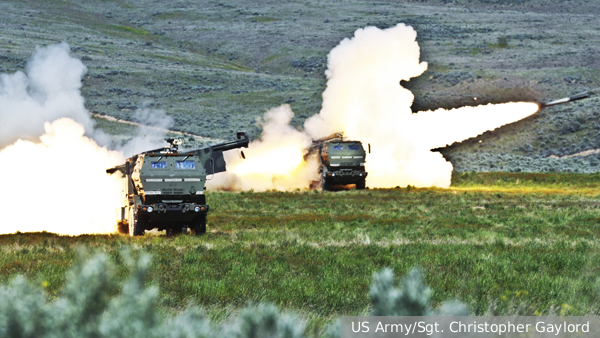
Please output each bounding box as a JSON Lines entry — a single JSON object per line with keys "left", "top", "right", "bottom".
{"left": 0, "top": 43, "right": 125, "bottom": 235}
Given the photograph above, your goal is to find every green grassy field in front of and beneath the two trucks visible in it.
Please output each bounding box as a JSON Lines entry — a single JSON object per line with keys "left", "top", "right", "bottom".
{"left": 0, "top": 173, "right": 600, "bottom": 320}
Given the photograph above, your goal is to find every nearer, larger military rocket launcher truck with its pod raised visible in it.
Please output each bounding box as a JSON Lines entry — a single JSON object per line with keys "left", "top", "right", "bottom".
{"left": 106, "top": 132, "right": 249, "bottom": 236}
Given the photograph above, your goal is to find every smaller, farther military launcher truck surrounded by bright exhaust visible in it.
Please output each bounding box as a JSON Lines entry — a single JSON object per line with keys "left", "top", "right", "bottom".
{"left": 309, "top": 133, "right": 371, "bottom": 190}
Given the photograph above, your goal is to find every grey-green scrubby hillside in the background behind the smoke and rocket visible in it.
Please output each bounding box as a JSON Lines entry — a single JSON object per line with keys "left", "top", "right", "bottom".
{"left": 0, "top": 0, "right": 600, "bottom": 171}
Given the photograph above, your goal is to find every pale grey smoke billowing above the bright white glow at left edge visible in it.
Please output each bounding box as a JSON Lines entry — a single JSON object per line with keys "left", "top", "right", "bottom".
{"left": 0, "top": 42, "right": 93, "bottom": 149}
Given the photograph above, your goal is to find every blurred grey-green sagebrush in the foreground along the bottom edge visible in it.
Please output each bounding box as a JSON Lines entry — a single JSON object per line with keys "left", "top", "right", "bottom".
{"left": 0, "top": 254, "right": 469, "bottom": 338}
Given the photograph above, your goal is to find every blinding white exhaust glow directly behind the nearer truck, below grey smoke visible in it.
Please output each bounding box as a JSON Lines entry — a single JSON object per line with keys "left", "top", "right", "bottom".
{"left": 0, "top": 118, "right": 125, "bottom": 235}
